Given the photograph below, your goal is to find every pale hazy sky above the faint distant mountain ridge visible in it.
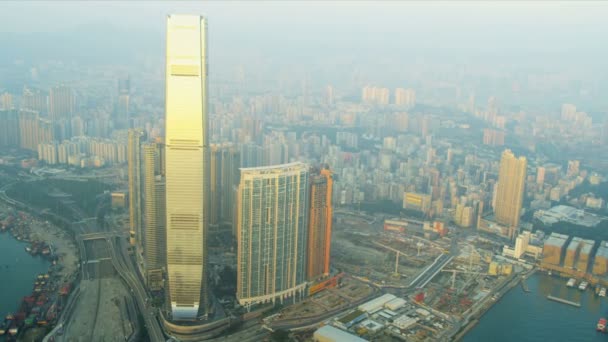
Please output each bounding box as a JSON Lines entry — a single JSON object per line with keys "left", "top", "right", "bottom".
{"left": 0, "top": 1, "right": 608, "bottom": 56}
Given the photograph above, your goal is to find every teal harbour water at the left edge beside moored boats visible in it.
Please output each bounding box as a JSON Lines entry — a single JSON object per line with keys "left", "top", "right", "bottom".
{"left": 0, "top": 233, "right": 50, "bottom": 320}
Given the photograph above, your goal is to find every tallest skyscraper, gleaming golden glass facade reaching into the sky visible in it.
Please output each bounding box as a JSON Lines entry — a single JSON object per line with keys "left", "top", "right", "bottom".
{"left": 165, "top": 15, "right": 210, "bottom": 321}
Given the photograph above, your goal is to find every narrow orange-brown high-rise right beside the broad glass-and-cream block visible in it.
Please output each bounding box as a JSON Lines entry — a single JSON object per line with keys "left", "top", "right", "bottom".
{"left": 308, "top": 169, "right": 333, "bottom": 280}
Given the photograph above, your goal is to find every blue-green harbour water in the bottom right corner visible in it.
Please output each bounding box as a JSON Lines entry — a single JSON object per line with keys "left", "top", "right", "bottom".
{"left": 463, "top": 273, "right": 608, "bottom": 342}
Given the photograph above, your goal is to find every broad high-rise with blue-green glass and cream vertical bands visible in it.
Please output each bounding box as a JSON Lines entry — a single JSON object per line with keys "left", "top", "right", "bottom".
{"left": 236, "top": 163, "right": 309, "bottom": 306}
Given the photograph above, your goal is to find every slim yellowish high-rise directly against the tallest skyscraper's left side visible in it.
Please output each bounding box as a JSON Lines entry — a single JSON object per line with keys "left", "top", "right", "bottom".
{"left": 142, "top": 143, "right": 166, "bottom": 291}
